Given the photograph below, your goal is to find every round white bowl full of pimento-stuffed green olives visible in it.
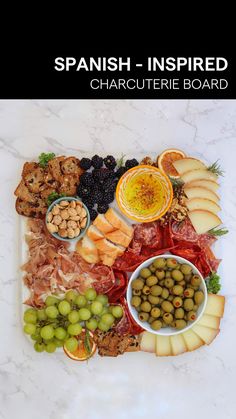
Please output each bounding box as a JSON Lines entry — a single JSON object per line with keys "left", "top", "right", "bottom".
{"left": 127, "top": 254, "right": 207, "bottom": 336}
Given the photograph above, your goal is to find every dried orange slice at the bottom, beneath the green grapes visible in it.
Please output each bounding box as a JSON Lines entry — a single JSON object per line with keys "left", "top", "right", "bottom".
{"left": 63, "top": 329, "right": 97, "bottom": 361}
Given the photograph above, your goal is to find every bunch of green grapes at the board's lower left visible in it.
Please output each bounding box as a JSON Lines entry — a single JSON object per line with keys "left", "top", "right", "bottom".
{"left": 24, "top": 288, "right": 123, "bottom": 353}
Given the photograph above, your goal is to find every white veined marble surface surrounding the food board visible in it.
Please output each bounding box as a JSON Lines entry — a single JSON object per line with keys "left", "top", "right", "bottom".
{"left": 0, "top": 100, "right": 236, "bottom": 419}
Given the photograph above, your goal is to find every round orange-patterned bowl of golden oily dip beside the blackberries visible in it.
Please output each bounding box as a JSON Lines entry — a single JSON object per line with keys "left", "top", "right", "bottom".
{"left": 116, "top": 165, "right": 173, "bottom": 223}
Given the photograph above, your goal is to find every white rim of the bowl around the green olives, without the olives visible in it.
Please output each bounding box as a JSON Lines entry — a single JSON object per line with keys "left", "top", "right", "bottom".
{"left": 126, "top": 254, "right": 207, "bottom": 336}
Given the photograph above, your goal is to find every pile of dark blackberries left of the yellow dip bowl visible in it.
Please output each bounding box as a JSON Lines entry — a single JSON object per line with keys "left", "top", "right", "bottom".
{"left": 77, "top": 154, "right": 139, "bottom": 221}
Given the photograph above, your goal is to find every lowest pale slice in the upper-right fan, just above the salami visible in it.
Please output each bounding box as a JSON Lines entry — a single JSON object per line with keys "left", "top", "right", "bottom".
{"left": 188, "top": 209, "right": 221, "bottom": 234}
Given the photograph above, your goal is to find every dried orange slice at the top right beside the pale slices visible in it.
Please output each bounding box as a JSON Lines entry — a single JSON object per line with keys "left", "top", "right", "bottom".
{"left": 157, "top": 148, "right": 186, "bottom": 178}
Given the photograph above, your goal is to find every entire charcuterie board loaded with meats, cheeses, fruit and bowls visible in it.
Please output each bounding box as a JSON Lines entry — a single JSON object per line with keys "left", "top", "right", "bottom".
{"left": 15, "top": 150, "right": 227, "bottom": 360}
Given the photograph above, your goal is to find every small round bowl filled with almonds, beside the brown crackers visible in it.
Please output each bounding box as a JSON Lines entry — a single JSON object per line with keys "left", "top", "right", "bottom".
{"left": 46, "top": 196, "right": 90, "bottom": 241}
